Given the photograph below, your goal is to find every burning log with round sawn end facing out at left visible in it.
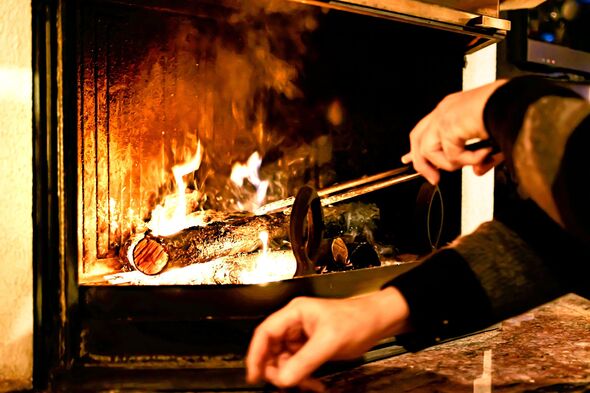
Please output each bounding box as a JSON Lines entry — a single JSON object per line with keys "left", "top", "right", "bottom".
{"left": 123, "top": 213, "right": 289, "bottom": 275}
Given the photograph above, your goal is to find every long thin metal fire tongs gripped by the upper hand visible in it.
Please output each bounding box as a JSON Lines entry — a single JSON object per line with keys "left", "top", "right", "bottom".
{"left": 254, "top": 166, "right": 421, "bottom": 215}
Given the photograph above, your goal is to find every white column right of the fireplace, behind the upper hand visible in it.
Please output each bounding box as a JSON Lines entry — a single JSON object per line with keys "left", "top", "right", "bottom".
{"left": 461, "top": 44, "right": 496, "bottom": 234}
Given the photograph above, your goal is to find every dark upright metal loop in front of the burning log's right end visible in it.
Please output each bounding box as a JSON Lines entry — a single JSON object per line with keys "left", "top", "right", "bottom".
{"left": 289, "top": 186, "right": 324, "bottom": 276}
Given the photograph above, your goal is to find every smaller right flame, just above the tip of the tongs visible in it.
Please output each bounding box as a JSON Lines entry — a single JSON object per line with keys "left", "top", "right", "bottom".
{"left": 230, "top": 151, "right": 269, "bottom": 211}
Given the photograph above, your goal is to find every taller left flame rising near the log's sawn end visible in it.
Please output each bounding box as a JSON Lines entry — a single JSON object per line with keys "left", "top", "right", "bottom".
{"left": 148, "top": 141, "right": 203, "bottom": 236}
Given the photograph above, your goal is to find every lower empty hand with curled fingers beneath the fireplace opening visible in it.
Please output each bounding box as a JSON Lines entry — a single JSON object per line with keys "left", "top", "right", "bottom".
{"left": 246, "top": 287, "right": 409, "bottom": 390}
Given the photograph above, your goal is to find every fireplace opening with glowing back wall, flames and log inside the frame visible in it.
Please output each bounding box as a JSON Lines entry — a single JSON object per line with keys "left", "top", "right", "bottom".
{"left": 77, "top": 1, "right": 465, "bottom": 284}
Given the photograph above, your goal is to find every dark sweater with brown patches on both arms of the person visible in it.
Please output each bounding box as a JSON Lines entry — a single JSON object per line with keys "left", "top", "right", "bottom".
{"left": 387, "top": 77, "right": 590, "bottom": 343}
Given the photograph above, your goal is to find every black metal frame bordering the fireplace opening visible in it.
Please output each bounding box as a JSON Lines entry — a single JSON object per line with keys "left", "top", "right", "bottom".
{"left": 33, "top": 0, "right": 509, "bottom": 391}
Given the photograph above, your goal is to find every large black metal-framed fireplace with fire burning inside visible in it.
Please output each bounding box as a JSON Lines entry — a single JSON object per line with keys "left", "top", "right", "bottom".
{"left": 34, "top": 0, "right": 507, "bottom": 390}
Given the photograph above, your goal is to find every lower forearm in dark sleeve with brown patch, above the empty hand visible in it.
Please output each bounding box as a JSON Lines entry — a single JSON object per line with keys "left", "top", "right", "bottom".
{"left": 388, "top": 211, "right": 590, "bottom": 345}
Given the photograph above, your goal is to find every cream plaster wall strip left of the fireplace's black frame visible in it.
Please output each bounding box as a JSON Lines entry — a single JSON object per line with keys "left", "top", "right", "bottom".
{"left": 0, "top": 0, "right": 33, "bottom": 391}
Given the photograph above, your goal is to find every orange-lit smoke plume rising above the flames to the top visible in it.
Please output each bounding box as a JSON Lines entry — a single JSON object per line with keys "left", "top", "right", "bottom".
{"left": 155, "top": 0, "right": 317, "bottom": 210}
